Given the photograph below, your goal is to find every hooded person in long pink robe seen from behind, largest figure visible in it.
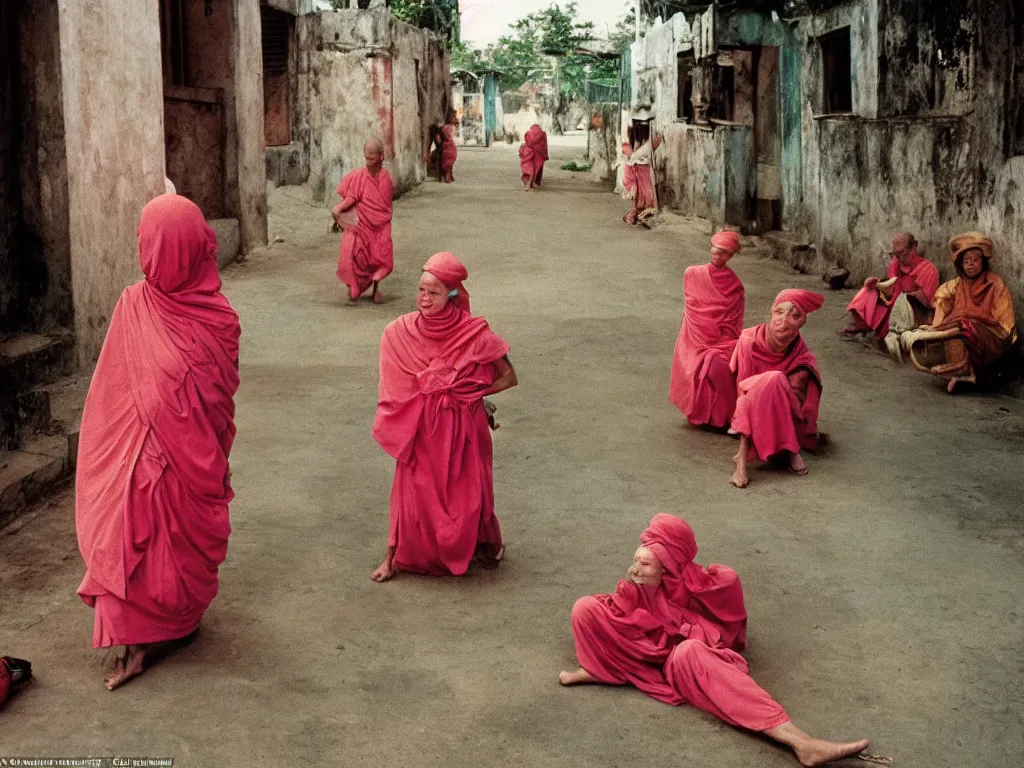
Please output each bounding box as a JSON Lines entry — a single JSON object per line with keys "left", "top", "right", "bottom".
{"left": 76, "top": 195, "right": 241, "bottom": 690}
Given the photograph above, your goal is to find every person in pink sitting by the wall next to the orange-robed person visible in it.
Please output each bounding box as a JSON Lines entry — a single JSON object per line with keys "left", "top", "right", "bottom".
{"left": 841, "top": 232, "right": 939, "bottom": 339}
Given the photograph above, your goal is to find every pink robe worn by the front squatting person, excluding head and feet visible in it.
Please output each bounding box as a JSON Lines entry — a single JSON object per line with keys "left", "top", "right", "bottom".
{"left": 730, "top": 325, "right": 821, "bottom": 460}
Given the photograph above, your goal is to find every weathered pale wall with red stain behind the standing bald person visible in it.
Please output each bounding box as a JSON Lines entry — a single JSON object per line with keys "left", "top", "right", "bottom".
{"left": 295, "top": 8, "right": 451, "bottom": 201}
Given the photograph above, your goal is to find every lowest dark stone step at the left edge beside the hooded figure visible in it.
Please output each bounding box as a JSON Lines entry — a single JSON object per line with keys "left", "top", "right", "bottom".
{"left": 0, "top": 431, "right": 78, "bottom": 528}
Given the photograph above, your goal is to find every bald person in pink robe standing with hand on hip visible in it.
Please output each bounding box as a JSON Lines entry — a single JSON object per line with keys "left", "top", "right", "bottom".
{"left": 332, "top": 138, "right": 394, "bottom": 304}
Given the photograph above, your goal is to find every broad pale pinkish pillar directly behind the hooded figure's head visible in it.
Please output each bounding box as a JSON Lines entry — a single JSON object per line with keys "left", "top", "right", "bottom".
{"left": 59, "top": 0, "right": 164, "bottom": 362}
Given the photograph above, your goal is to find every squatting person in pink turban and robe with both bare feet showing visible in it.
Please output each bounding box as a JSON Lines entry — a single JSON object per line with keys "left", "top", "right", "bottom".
{"left": 729, "top": 288, "right": 824, "bottom": 488}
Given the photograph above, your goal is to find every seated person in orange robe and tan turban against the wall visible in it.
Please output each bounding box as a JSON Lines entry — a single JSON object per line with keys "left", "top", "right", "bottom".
{"left": 900, "top": 232, "right": 1017, "bottom": 392}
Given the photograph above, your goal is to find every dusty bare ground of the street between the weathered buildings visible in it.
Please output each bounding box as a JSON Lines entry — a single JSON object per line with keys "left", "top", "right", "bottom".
{"left": 0, "top": 140, "right": 1024, "bottom": 768}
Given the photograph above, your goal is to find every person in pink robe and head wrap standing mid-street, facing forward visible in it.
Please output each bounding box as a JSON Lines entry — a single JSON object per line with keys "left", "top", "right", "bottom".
{"left": 371, "top": 253, "right": 518, "bottom": 582}
